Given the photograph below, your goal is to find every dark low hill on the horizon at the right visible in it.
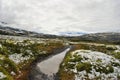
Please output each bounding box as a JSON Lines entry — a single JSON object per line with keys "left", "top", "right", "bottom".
{"left": 70, "top": 32, "right": 120, "bottom": 44}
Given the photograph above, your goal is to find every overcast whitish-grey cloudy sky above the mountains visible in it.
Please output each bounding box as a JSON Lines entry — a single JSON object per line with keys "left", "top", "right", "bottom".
{"left": 0, "top": 0, "right": 120, "bottom": 34}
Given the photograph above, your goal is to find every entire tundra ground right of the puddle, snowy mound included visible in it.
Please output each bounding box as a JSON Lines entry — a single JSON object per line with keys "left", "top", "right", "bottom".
{"left": 58, "top": 43, "right": 120, "bottom": 80}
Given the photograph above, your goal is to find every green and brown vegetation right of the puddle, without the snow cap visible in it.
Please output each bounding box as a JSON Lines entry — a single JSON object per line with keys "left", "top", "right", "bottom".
{"left": 59, "top": 42, "right": 120, "bottom": 80}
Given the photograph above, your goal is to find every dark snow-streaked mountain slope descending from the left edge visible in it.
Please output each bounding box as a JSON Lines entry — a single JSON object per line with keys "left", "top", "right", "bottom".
{"left": 0, "top": 22, "right": 56, "bottom": 38}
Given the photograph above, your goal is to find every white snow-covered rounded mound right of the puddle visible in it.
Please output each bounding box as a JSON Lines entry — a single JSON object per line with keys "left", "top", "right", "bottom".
{"left": 69, "top": 50, "right": 120, "bottom": 80}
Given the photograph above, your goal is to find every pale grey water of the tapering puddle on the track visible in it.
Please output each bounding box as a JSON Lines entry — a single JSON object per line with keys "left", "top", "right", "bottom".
{"left": 37, "top": 48, "right": 69, "bottom": 76}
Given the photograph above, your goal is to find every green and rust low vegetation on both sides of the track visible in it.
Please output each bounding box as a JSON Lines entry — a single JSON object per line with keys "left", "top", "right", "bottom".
{"left": 0, "top": 35, "right": 120, "bottom": 80}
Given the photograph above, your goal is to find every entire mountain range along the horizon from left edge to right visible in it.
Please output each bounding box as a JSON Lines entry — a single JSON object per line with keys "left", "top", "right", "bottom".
{"left": 0, "top": 22, "right": 120, "bottom": 44}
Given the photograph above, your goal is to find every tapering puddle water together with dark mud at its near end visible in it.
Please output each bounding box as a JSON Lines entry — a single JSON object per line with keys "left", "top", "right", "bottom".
{"left": 29, "top": 47, "right": 70, "bottom": 80}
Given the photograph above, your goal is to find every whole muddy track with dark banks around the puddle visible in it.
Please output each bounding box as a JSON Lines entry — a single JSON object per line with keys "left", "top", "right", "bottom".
{"left": 28, "top": 46, "right": 71, "bottom": 80}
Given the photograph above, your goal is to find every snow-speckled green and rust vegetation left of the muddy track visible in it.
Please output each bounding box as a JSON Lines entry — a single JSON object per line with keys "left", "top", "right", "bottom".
{"left": 0, "top": 39, "right": 64, "bottom": 80}
